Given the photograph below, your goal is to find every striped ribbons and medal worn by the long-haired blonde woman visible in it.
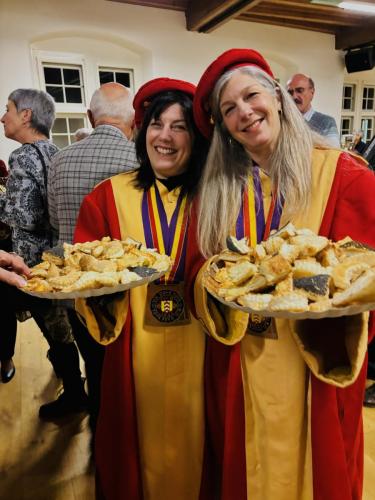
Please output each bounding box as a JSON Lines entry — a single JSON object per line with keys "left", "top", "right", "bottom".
{"left": 236, "top": 167, "right": 282, "bottom": 339}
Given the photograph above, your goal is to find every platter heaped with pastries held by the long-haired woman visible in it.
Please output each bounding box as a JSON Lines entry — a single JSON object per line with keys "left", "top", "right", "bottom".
{"left": 204, "top": 223, "right": 375, "bottom": 319}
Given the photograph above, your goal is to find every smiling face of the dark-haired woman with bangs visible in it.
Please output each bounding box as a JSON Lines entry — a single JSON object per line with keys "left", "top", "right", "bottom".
{"left": 146, "top": 104, "right": 192, "bottom": 179}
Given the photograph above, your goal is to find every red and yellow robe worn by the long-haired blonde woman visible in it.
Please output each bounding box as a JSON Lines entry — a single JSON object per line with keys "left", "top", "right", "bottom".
{"left": 187, "top": 150, "right": 375, "bottom": 500}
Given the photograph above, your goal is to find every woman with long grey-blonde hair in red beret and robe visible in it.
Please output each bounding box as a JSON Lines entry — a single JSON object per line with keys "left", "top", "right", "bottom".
{"left": 188, "top": 49, "right": 375, "bottom": 500}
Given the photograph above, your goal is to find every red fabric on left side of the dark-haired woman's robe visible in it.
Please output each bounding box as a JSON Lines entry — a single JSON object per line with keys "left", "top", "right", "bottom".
{"left": 74, "top": 180, "right": 143, "bottom": 500}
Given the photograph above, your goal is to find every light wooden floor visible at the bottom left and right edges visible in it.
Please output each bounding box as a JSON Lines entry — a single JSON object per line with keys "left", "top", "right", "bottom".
{"left": 0, "top": 320, "right": 375, "bottom": 500}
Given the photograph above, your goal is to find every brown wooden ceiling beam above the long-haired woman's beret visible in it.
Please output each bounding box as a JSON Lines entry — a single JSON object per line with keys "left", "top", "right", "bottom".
{"left": 185, "top": 0, "right": 261, "bottom": 33}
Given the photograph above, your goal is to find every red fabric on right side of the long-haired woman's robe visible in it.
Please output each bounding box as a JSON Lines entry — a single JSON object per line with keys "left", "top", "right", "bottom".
{"left": 311, "top": 153, "right": 375, "bottom": 500}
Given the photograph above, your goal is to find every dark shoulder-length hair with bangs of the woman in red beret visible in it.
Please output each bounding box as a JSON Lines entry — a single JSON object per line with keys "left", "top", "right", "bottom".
{"left": 135, "top": 90, "right": 208, "bottom": 198}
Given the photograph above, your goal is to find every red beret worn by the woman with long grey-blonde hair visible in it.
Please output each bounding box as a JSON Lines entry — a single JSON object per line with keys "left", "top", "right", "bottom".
{"left": 194, "top": 49, "right": 274, "bottom": 138}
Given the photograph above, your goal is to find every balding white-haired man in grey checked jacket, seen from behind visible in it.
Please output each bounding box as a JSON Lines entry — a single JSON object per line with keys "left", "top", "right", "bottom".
{"left": 48, "top": 82, "right": 138, "bottom": 430}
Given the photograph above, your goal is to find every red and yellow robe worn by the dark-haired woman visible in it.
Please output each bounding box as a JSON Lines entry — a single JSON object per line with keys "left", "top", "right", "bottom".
{"left": 75, "top": 173, "right": 205, "bottom": 500}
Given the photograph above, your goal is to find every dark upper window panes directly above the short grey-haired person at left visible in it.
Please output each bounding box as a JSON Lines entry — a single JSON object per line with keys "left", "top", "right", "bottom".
{"left": 43, "top": 63, "right": 85, "bottom": 104}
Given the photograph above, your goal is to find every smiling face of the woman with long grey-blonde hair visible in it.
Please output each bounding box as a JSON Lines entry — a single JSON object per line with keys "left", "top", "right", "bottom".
{"left": 219, "top": 72, "right": 280, "bottom": 165}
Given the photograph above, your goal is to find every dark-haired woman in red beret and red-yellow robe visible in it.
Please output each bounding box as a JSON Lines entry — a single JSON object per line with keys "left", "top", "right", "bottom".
{"left": 75, "top": 78, "right": 207, "bottom": 500}
